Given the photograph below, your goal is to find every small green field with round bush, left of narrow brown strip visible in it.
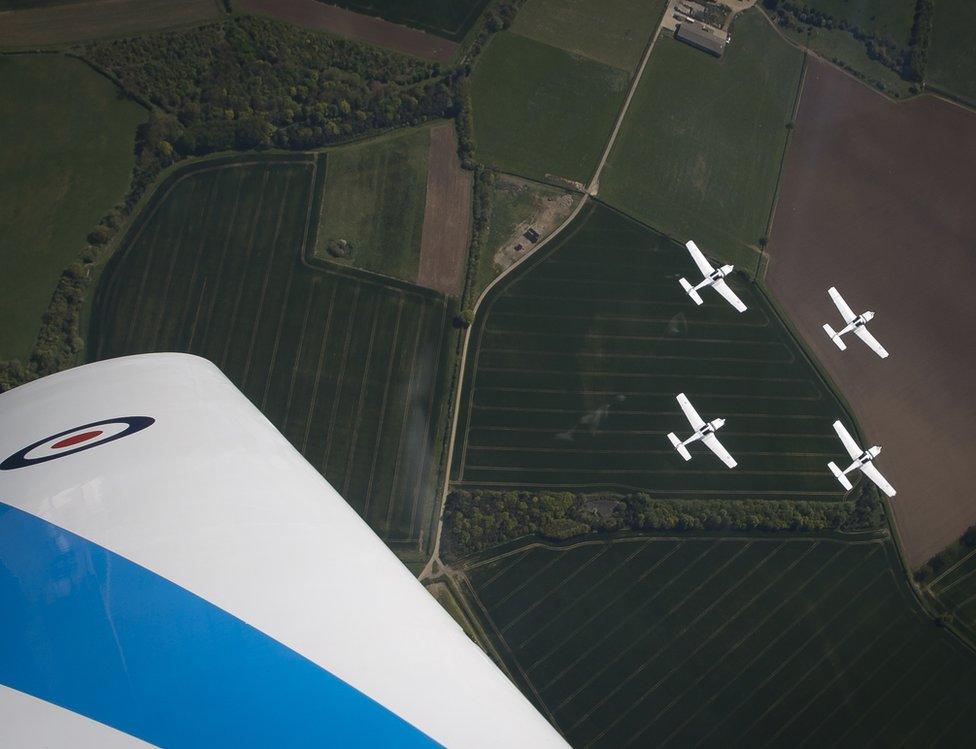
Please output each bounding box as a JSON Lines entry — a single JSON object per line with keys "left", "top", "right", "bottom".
{"left": 315, "top": 127, "right": 430, "bottom": 282}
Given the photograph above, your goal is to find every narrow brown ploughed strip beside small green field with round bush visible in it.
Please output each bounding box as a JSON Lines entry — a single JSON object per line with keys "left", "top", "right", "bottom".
{"left": 417, "top": 122, "right": 471, "bottom": 296}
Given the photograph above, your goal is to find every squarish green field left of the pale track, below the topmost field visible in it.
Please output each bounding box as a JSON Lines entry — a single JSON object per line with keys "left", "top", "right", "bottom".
{"left": 471, "top": 31, "right": 627, "bottom": 183}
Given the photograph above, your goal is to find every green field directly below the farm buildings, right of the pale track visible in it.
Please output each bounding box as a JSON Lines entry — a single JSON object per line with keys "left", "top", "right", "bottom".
{"left": 600, "top": 10, "right": 804, "bottom": 273}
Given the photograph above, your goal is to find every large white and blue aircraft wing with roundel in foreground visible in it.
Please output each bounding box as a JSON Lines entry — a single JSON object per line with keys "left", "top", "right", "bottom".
{"left": 0, "top": 354, "right": 568, "bottom": 749}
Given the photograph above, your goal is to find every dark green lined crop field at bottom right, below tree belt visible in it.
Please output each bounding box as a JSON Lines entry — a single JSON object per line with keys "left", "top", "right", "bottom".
{"left": 466, "top": 536, "right": 976, "bottom": 749}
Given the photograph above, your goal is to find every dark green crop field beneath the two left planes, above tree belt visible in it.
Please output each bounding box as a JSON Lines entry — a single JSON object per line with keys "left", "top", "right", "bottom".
{"left": 454, "top": 206, "right": 843, "bottom": 500}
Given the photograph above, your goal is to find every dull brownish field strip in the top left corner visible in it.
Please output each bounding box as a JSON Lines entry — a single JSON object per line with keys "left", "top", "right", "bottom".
{"left": 0, "top": 0, "right": 220, "bottom": 50}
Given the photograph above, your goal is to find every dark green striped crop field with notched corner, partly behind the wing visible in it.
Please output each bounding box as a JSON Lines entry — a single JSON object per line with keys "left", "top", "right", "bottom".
{"left": 90, "top": 156, "right": 450, "bottom": 547}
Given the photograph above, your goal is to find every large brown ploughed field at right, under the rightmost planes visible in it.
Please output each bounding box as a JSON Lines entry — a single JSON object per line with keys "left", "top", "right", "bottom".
{"left": 766, "top": 60, "right": 976, "bottom": 566}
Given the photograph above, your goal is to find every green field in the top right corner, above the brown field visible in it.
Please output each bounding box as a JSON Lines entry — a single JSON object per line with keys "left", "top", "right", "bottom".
{"left": 925, "top": 0, "right": 976, "bottom": 106}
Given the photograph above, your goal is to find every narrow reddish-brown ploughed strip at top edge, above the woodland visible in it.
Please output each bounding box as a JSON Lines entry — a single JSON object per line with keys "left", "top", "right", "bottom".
{"left": 235, "top": 0, "right": 457, "bottom": 62}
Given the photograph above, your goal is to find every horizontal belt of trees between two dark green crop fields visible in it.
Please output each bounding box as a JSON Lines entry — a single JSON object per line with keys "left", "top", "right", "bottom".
{"left": 444, "top": 485, "right": 884, "bottom": 557}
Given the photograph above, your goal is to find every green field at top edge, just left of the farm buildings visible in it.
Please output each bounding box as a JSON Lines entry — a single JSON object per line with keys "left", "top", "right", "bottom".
{"left": 512, "top": 0, "right": 667, "bottom": 73}
